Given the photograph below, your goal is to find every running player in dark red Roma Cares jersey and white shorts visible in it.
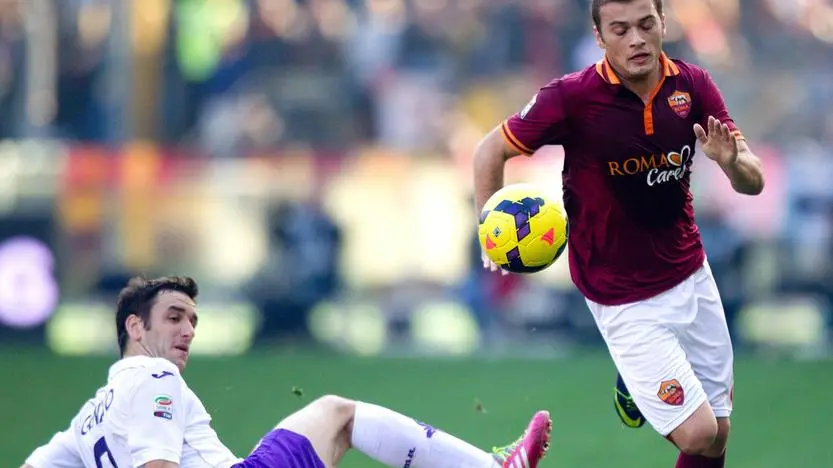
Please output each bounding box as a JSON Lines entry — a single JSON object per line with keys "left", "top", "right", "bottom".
{"left": 474, "top": 0, "right": 764, "bottom": 468}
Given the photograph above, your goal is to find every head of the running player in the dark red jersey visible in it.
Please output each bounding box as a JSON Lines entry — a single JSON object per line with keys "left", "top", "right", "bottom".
{"left": 595, "top": 0, "right": 665, "bottom": 81}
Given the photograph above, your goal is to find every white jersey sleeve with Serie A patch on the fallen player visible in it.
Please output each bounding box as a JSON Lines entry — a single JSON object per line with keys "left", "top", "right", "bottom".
{"left": 127, "top": 360, "right": 187, "bottom": 467}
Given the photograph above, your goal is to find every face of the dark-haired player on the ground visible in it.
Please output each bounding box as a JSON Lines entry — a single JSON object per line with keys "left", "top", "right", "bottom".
{"left": 139, "top": 291, "right": 197, "bottom": 371}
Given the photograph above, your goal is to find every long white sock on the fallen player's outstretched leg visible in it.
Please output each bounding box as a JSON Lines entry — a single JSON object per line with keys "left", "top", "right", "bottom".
{"left": 351, "top": 402, "right": 500, "bottom": 468}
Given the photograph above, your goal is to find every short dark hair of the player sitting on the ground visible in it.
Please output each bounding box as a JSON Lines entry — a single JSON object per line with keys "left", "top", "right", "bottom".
{"left": 116, "top": 276, "right": 199, "bottom": 356}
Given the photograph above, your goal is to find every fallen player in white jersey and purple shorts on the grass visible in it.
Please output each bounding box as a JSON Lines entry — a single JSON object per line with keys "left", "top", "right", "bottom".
{"left": 22, "top": 277, "right": 552, "bottom": 468}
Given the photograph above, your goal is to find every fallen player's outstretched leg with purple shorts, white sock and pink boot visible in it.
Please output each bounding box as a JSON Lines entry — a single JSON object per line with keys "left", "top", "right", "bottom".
{"left": 243, "top": 396, "right": 551, "bottom": 468}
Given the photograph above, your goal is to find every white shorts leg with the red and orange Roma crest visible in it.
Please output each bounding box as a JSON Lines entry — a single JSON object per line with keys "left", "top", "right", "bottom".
{"left": 588, "top": 298, "right": 706, "bottom": 436}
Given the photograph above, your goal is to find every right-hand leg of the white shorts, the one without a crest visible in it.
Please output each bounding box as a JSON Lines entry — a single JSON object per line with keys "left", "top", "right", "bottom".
{"left": 680, "top": 268, "right": 734, "bottom": 418}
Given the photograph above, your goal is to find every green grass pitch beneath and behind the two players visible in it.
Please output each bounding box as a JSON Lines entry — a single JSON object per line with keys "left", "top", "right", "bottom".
{"left": 0, "top": 348, "right": 833, "bottom": 468}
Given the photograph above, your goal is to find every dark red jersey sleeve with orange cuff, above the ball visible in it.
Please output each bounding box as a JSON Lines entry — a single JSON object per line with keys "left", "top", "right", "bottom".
{"left": 501, "top": 80, "right": 567, "bottom": 155}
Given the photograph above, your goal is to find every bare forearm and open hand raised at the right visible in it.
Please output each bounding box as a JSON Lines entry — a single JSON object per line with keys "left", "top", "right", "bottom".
{"left": 694, "top": 116, "right": 764, "bottom": 195}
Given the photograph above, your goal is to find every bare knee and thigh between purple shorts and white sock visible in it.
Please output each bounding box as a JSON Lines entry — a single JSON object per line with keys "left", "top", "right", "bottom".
{"left": 277, "top": 395, "right": 355, "bottom": 467}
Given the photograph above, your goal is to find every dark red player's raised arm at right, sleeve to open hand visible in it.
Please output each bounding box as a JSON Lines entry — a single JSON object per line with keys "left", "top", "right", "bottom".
{"left": 694, "top": 71, "right": 764, "bottom": 195}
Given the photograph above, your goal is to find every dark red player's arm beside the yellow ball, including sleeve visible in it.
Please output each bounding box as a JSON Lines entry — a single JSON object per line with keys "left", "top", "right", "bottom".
{"left": 474, "top": 80, "right": 567, "bottom": 213}
